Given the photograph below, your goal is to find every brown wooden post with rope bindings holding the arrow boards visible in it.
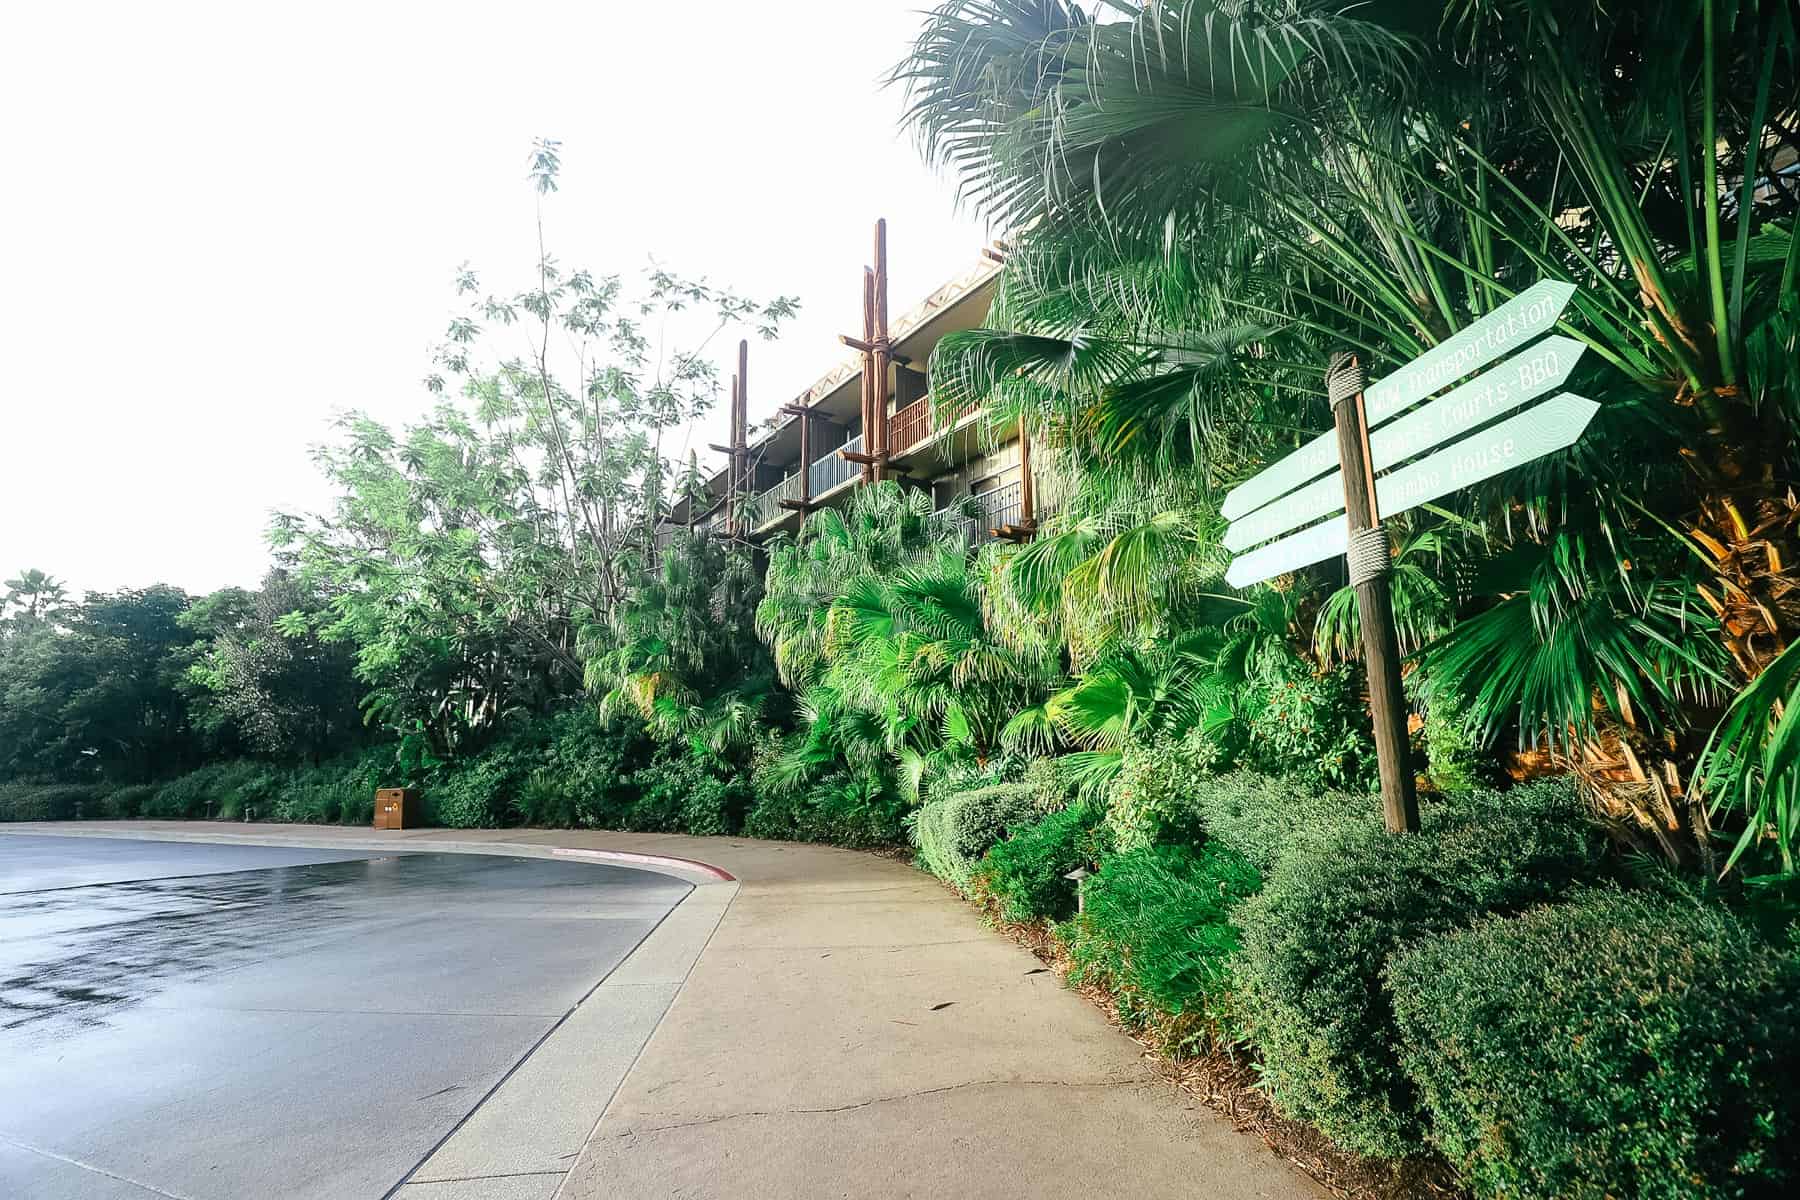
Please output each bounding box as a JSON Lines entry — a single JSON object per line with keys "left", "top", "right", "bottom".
{"left": 1325, "top": 354, "right": 1418, "bottom": 833}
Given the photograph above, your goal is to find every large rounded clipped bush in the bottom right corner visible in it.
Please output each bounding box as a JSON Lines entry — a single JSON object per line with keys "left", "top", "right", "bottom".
{"left": 1388, "top": 889, "right": 1800, "bottom": 1200}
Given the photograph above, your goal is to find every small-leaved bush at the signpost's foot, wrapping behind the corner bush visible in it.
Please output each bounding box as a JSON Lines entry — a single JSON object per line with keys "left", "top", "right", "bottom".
{"left": 1235, "top": 781, "right": 1595, "bottom": 1157}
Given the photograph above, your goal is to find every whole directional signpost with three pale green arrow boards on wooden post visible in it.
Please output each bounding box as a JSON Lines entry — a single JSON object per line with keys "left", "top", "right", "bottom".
{"left": 1220, "top": 281, "right": 1598, "bottom": 831}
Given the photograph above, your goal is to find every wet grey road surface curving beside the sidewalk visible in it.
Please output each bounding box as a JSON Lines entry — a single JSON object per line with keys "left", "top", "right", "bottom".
{"left": 0, "top": 835, "right": 689, "bottom": 1200}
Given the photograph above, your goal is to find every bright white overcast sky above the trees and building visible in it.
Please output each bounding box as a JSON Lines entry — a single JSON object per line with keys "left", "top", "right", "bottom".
{"left": 0, "top": 0, "right": 985, "bottom": 592}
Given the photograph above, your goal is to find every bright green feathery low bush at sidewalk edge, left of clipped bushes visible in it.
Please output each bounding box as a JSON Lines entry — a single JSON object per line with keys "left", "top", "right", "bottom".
{"left": 1062, "top": 842, "right": 1262, "bottom": 1043}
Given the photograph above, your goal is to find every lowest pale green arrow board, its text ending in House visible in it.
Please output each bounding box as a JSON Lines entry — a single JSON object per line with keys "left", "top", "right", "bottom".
{"left": 1226, "top": 392, "right": 1600, "bottom": 588}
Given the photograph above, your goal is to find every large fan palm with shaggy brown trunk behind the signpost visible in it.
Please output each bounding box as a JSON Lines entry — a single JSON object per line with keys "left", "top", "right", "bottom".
{"left": 896, "top": 0, "right": 1800, "bottom": 874}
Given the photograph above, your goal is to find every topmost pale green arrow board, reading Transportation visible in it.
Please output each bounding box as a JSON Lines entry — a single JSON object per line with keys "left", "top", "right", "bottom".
{"left": 1219, "top": 279, "right": 1575, "bottom": 520}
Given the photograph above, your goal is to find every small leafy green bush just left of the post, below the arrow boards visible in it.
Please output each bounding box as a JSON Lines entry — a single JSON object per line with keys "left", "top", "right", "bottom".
{"left": 1238, "top": 655, "right": 1377, "bottom": 792}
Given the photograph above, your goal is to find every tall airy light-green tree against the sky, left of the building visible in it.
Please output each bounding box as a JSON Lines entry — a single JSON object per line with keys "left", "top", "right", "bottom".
{"left": 272, "top": 140, "right": 796, "bottom": 756}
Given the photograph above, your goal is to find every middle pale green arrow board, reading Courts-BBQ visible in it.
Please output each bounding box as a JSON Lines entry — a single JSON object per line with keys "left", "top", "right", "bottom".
{"left": 1224, "top": 336, "right": 1586, "bottom": 551}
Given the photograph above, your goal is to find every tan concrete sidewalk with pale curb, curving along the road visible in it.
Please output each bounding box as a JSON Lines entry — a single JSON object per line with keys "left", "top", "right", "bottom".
{"left": 10, "top": 822, "right": 1327, "bottom": 1200}
